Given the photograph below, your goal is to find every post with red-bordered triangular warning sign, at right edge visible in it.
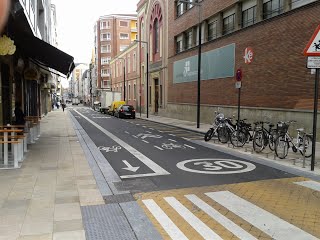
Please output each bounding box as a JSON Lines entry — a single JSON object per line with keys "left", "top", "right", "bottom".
{"left": 303, "top": 25, "right": 320, "bottom": 171}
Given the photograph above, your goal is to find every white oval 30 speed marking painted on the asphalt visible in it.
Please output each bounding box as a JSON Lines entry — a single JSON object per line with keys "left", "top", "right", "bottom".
{"left": 177, "top": 158, "right": 256, "bottom": 174}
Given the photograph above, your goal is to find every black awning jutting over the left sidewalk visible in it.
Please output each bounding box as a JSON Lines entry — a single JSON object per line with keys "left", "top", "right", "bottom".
{"left": 14, "top": 32, "right": 75, "bottom": 76}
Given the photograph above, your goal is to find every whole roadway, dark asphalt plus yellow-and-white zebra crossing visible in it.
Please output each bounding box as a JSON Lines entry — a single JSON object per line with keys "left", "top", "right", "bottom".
{"left": 70, "top": 107, "right": 320, "bottom": 239}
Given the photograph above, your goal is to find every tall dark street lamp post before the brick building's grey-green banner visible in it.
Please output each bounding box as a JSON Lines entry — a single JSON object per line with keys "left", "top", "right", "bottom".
{"left": 178, "top": 0, "right": 201, "bottom": 128}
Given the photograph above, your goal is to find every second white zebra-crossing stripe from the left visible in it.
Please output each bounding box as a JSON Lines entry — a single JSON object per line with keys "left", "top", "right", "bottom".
{"left": 164, "top": 197, "right": 222, "bottom": 240}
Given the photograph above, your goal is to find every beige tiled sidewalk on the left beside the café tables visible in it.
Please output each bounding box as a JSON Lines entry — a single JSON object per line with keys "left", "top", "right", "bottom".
{"left": 0, "top": 111, "right": 104, "bottom": 240}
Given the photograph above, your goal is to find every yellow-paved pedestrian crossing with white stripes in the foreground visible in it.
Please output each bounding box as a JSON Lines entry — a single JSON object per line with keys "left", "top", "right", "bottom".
{"left": 134, "top": 177, "right": 320, "bottom": 239}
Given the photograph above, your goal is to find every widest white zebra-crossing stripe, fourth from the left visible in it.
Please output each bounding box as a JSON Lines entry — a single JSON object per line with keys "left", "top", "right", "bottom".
{"left": 206, "top": 191, "right": 318, "bottom": 240}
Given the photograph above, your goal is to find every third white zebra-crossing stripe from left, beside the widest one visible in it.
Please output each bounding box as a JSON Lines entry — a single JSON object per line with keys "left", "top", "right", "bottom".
{"left": 185, "top": 194, "right": 256, "bottom": 240}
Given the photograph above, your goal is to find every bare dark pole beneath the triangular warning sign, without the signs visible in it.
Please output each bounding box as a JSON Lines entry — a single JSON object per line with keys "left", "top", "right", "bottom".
{"left": 311, "top": 68, "right": 320, "bottom": 171}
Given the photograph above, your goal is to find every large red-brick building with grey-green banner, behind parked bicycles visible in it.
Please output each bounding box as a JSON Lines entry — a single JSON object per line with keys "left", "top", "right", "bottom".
{"left": 168, "top": 0, "right": 320, "bottom": 132}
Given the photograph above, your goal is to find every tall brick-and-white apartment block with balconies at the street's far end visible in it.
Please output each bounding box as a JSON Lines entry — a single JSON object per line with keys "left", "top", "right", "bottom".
{"left": 94, "top": 14, "right": 137, "bottom": 99}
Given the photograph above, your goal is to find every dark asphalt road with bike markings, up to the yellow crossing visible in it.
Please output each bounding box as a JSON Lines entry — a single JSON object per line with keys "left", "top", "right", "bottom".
{"left": 71, "top": 108, "right": 294, "bottom": 191}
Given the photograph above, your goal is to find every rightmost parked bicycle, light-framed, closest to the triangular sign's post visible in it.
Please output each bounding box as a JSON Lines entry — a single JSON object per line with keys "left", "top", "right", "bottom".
{"left": 275, "top": 121, "right": 312, "bottom": 159}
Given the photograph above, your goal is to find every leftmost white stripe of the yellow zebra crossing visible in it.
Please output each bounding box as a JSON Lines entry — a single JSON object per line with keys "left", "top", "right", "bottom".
{"left": 142, "top": 199, "right": 188, "bottom": 240}
